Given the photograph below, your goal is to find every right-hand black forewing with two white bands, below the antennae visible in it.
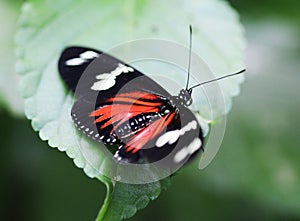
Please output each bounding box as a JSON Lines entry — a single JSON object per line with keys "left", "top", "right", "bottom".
{"left": 131, "top": 106, "right": 204, "bottom": 167}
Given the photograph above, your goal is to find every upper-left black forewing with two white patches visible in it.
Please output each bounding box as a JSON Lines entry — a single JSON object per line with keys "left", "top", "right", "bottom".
{"left": 58, "top": 47, "right": 171, "bottom": 104}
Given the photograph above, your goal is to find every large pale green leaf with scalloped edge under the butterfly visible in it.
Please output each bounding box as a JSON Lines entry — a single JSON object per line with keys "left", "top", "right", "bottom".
{"left": 15, "top": 0, "right": 245, "bottom": 220}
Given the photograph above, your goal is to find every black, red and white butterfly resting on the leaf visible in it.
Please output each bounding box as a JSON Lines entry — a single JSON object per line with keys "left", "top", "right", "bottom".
{"left": 58, "top": 47, "right": 204, "bottom": 165}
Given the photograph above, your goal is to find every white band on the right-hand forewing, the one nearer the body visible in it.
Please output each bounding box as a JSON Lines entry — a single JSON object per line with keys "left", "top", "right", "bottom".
{"left": 155, "top": 120, "right": 197, "bottom": 147}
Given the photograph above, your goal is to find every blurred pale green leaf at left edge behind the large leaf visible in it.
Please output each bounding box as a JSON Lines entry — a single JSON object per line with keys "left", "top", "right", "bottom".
{"left": 0, "top": 0, "right": 23, "bottom": 116}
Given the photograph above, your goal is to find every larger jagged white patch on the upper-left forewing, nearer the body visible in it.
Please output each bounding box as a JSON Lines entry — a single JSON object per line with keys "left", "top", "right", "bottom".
{"left": 91, "top": 63, "right": 134, "bottom": 91}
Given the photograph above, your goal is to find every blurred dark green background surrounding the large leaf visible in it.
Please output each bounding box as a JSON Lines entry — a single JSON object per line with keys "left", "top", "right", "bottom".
{"left": 0, "top": 0, "right": 300, "bottom": 221}
